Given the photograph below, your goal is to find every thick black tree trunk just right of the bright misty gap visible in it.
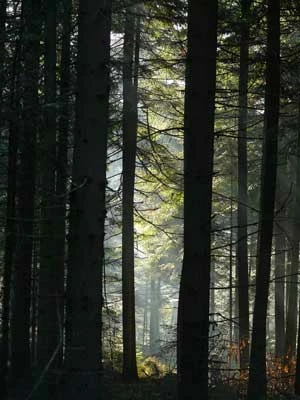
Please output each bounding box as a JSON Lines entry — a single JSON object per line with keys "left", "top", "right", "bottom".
{"left": 177, "top": 0, "right": 218, "bottom": 400}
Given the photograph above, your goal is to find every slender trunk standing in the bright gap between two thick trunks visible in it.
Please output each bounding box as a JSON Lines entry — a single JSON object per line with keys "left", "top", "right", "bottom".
{"left": 122, "top": 0, "right": 139, "bottom": 381}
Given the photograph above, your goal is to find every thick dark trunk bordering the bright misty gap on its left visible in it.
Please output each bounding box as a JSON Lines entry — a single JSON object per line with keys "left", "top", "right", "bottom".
{"left": 65, "top": 0, "right": 111, "bottom": 400}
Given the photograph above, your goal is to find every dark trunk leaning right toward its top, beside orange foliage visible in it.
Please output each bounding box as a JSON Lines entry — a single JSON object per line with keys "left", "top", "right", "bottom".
{"left": 248, "top": 0, "right": 280, "bottom": 400}
